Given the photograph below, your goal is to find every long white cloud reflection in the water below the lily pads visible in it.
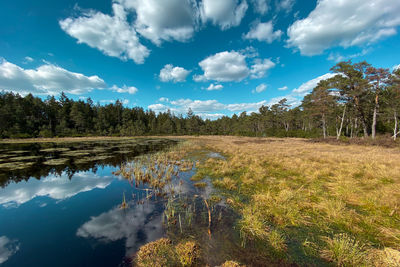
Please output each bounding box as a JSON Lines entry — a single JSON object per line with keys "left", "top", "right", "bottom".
{"left": 0, "top": 172, "right": 113, "bottom": 206}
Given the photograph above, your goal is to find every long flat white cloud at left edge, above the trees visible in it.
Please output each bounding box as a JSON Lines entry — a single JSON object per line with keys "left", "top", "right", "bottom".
{"left": 0, "top": 59, "right": 106, "bottom": 95}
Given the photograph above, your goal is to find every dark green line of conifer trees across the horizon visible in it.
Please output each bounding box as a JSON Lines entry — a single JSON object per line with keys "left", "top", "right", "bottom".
{"left": 0, "top": 61, "right": 400, "bottom": 139}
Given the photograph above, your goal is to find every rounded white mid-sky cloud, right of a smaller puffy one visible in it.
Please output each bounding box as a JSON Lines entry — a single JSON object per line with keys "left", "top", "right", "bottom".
{"left": 194, "top": 51, "right": 249, "bottom": 82}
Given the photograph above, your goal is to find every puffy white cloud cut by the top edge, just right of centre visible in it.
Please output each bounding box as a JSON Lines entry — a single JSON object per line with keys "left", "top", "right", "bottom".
{"left": 200, "top": 0, "right": 248, "bottom": 30}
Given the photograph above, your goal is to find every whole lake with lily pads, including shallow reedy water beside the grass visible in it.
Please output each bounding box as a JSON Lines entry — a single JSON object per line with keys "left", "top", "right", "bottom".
{"left": 0, "top": 139, "right": 236, "bottom": 266}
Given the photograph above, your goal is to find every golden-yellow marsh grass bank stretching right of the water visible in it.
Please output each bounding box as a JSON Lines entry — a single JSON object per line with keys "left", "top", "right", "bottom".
{"left": 192, "top": 137, "right": 400, "bottom": 266}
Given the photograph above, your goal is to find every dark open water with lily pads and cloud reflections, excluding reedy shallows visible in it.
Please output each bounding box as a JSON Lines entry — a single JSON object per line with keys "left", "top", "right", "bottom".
{"left": 0, "top": 140, "right": 176, "bottom": 266}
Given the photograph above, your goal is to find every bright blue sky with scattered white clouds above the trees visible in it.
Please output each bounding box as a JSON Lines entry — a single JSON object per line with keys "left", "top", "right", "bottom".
{"left": 0, "top": 0, "right": 400, "bottom": 119}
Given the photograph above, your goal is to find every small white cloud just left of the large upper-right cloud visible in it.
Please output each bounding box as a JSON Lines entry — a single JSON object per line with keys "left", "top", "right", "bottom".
{"left": 244, "top": 21, "right": 282, "bottom": 44}
